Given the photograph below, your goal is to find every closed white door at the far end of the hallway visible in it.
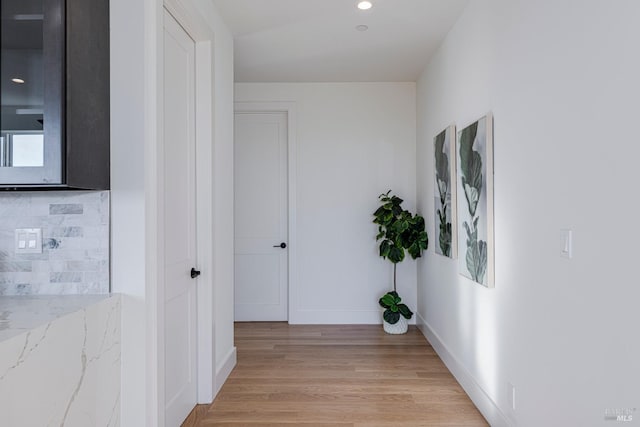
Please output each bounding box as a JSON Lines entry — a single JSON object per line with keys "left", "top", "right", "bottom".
{"left": 234, "top": 112, "right": 288, "bottom": 321}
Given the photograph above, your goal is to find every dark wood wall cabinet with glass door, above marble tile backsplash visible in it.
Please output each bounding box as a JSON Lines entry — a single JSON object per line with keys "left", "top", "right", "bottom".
{"left": 0, "top": 0, "right": 110, "bottom": 190}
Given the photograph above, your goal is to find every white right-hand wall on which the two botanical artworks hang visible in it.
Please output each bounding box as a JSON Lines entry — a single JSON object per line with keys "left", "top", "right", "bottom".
{"left": 417, "top": 0, "right": 640, "bottom": 426}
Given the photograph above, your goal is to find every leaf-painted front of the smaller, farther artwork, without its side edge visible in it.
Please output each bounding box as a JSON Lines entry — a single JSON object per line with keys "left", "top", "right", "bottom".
{"left": 433, "top": 126, "right": 455, "bottom": 258}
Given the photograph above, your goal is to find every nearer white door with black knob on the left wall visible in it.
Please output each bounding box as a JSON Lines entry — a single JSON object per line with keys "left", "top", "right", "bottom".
{"left": 160, "top": 11, "right": 197, "bottom": 426}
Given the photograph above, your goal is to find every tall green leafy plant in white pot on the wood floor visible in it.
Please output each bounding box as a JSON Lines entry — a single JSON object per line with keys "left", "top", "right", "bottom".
{"left": 373, "top": 190, "right": 429, "bottom": 334}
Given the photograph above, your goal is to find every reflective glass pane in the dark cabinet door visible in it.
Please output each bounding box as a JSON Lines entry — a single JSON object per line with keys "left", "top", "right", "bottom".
{"left": 0, "top": 0, "right": 44, "bottom": 167}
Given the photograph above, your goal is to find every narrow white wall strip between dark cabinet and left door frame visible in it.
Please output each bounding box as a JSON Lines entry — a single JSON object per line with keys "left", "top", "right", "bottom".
{"left": 110, "top": 0, "right": 153, "bottom": 426}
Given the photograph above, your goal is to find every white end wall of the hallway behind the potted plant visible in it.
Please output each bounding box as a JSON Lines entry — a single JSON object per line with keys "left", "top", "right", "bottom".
{"left": 236, "top": 83, "right": 416, "bottom": 323}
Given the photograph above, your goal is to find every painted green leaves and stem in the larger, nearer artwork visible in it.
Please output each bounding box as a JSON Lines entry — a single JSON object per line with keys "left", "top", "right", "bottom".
{"left": 460, "top": 122, "right": 487, "bottom": 283}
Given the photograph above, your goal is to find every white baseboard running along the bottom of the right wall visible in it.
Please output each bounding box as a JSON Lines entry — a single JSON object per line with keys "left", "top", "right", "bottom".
{"left": 416, "top": 314, "right": 512, "bottom": 427}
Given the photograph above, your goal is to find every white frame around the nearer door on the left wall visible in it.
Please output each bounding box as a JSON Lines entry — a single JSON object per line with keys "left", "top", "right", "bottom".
{"left": 156, "top": 0, "right": 219, "bottom": 426}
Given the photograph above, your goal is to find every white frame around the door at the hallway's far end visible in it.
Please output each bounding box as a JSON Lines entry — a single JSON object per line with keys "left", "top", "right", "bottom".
{"left": 234, "top": 101, "right": 298, "bottom": 324}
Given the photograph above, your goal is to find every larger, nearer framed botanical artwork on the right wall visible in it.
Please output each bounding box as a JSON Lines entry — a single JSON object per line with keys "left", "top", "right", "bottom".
{"left": 456, "top": 114, "right": 495, "bottom": 288}
